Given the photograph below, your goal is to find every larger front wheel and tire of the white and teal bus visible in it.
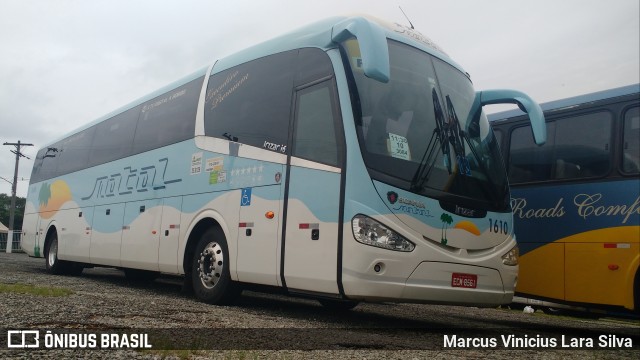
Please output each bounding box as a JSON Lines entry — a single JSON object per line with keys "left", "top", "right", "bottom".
{"left": 191, "top": 227, "right": 240, "bottom": 305}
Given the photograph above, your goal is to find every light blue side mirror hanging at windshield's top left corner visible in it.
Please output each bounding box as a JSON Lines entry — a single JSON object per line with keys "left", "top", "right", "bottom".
{"left": 331, "top": 17, "right": 390, "bottom": 83}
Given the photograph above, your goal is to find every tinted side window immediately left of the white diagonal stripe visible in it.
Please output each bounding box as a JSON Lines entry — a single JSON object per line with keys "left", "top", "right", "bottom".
{"left": 133, "top": 78, "right": 204, "bottom": 154}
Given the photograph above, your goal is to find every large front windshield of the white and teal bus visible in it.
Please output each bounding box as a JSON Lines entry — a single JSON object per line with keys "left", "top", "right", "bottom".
{"left": 343, "top": 39, "right": 509, "bottom": 212}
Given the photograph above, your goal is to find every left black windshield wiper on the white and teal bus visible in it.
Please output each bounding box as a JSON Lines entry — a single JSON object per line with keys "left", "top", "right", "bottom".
{"left": 410, "top": 89, "right": 451, "bottom": 191}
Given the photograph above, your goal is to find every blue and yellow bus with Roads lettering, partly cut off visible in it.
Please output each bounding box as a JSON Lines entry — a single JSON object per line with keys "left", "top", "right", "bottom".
{"left": 491, "top": 84, "right": 640, "bottom": 312}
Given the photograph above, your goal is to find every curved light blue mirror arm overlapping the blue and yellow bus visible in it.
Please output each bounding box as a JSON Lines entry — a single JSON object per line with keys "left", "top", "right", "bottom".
{"left": 471, "top": 90, "right": 547, "bottom": 145}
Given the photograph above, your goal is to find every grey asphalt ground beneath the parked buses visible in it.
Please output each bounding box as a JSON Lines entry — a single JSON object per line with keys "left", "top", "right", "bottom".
{"left": 0, "top": 253, "right": 640, "bottom": 359}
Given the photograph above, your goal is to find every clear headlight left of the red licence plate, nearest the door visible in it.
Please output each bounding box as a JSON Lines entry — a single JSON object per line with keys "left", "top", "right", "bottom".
{"left": 351, "top": 215, "right": 416, "bottom": 252}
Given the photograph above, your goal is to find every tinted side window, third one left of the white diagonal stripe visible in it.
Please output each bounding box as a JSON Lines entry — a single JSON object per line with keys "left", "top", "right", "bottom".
{"left": 56, "top": 126, "right": 96, "bottom": 176}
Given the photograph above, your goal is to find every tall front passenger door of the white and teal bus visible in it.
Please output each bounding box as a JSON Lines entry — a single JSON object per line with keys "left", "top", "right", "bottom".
{"left": 282, "top": 80, "right": 344, "bottom": 294}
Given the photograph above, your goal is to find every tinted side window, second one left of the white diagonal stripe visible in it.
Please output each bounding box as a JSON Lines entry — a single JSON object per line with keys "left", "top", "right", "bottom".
{"left": 89, "top": 106, "right": 140, "bottom": 166}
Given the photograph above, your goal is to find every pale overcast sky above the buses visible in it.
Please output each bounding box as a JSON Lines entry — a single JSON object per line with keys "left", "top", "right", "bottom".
{"left": 0, "top": 0, "right": 640, "bottom": 196}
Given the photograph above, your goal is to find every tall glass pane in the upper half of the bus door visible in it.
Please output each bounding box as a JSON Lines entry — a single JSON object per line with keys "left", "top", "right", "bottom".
{"left": 293, "top": 82, "right": 339, "bottom": 166}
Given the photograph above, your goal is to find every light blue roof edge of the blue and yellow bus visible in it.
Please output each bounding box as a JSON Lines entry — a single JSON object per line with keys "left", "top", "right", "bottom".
{"left": 488, "top": 84, "right": 640, "bottom": 121}
